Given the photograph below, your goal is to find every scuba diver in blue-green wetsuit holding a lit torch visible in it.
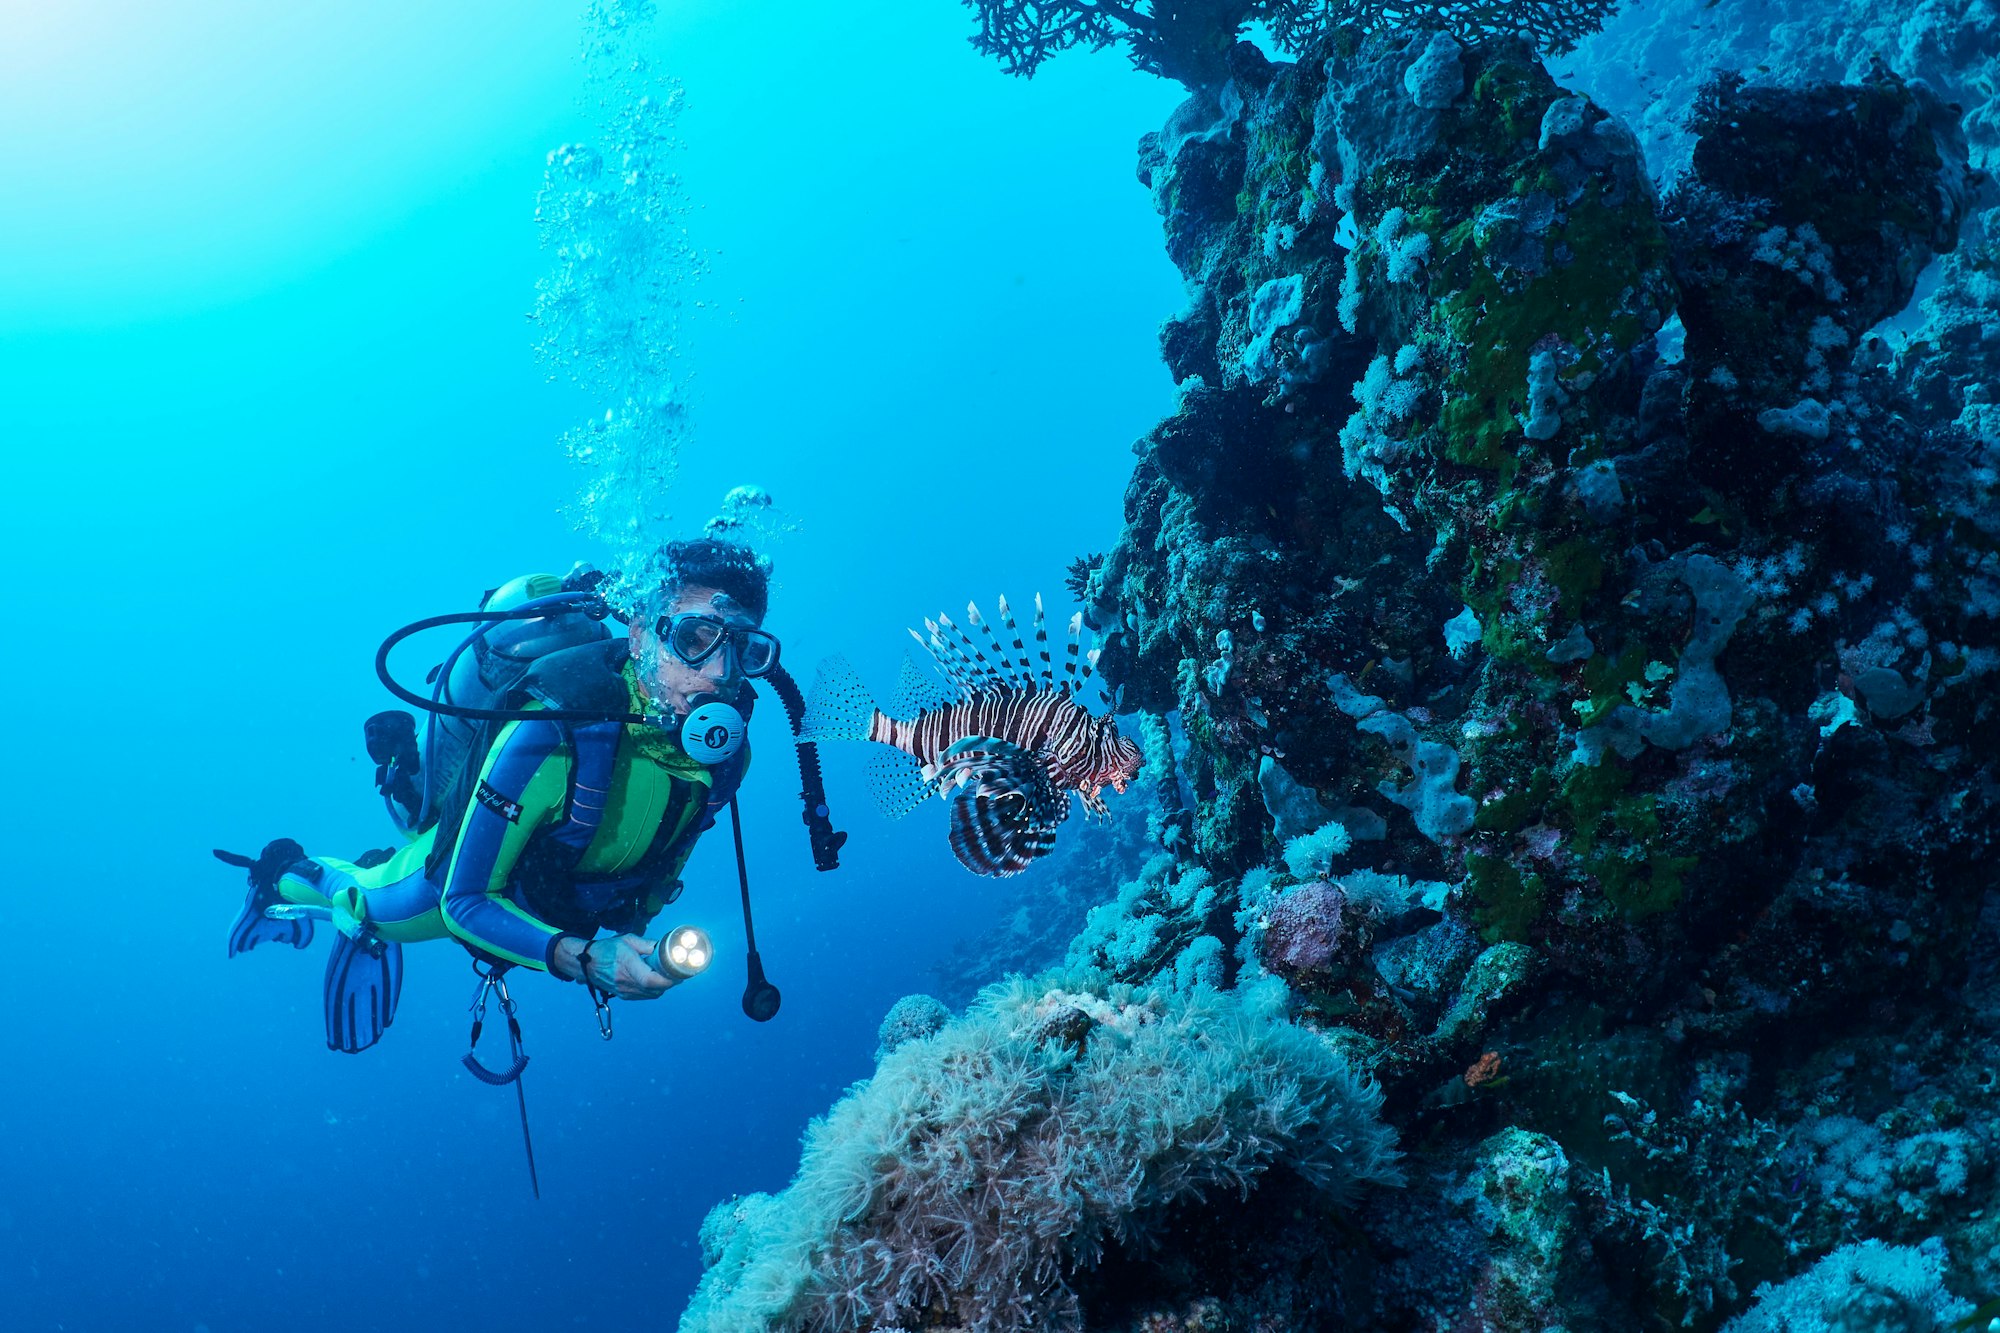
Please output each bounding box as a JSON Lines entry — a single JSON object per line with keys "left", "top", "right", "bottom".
{"left": 216, "top": 538, "right": 846, "bottom": 1056}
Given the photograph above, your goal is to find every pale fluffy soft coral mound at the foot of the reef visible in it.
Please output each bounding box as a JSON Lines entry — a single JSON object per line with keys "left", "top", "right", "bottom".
{"left": 680, "top": 979, "right": 1400, "bottom": 1333}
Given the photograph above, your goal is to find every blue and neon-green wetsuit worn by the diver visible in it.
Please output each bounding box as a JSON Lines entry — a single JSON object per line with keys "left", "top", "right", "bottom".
{"left": 266, "top": 662, "right": 748, "bottom": 971}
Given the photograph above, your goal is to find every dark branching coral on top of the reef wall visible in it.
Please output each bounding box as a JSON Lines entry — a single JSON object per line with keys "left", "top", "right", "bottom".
{"left": 966, "top": 0, "right": 1618, "bottom": 88}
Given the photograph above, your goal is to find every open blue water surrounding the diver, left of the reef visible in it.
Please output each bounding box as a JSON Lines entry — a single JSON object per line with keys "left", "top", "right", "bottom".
{"left": 0, "top": 0, "right": 1180, "bottom": 1333}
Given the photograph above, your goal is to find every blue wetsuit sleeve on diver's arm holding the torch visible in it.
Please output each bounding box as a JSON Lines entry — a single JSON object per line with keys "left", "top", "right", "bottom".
{"left": 442, "top": 723, "right": 568, "bottom": 971}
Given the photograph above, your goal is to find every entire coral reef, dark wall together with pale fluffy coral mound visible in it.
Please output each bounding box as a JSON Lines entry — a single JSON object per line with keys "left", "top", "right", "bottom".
{"left": 690, "top": 0, "right": 2000, "bottom": 1331}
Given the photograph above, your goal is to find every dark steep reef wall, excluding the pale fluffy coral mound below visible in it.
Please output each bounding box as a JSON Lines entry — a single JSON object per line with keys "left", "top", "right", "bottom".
{"left": 1090, "top": 20, "right": 2000, "bottom": 1327}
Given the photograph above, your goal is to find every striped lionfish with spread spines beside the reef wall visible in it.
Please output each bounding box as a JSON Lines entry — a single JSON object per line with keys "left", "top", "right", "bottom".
{"left": 800, "top": 594, "right": 1140, "bottom": 875}
